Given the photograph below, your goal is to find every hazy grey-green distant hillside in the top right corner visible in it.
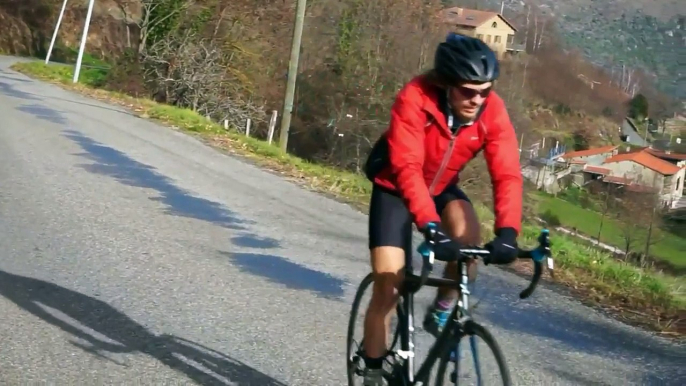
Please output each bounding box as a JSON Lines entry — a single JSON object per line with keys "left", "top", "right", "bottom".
{"left": 498, "top": 0, "right": 686, "bottom": 99}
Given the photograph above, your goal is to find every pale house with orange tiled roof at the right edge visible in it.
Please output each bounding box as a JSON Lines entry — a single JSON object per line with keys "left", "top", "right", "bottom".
{"left": 603, "top": 149, "right": 686, "bottom": 205}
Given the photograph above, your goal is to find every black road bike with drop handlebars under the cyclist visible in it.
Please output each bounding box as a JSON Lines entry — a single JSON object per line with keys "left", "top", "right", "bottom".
{"left": 347, "top": 229, "right": 553, "bottom": 386}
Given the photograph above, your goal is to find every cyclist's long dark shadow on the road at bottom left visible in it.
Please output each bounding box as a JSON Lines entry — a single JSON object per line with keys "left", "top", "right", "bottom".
{"left": 0, "top": 270, "right": 285, "bottom": 386}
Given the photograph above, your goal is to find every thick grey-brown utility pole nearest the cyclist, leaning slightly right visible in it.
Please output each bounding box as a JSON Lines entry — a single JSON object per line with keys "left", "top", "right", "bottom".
{"left": 279, "top": 0, "right": 307, "bottom": 151}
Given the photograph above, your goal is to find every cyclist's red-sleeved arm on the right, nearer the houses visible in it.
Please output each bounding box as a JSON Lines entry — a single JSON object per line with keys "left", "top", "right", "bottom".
{"left": 484, "top": 96, "right": 524, "bottom": 234}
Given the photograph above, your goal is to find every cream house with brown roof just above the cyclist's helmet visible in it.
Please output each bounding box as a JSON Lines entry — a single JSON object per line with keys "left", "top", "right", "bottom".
{"left": 443, "top": 7, "right": 517, "bottom": 58}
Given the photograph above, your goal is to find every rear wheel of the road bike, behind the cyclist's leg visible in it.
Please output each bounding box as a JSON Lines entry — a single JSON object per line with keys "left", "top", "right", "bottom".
{"left": 346, "top": 273, "right": 400, "bottom": 386}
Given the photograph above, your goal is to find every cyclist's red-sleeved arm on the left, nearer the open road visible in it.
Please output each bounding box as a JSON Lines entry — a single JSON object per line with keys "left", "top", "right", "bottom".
{"left": 387, "top": 87, "right": 440, "bottom": 229}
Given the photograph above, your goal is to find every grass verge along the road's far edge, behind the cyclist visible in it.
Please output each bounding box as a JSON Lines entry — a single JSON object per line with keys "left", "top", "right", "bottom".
{"left": 12, "top": 62, "right": 686, "bottom": 337}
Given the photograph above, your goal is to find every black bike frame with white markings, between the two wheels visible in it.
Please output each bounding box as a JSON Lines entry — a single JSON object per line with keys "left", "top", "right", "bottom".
{"left": 396, "top": 255, "right": 476, "bottom": 386}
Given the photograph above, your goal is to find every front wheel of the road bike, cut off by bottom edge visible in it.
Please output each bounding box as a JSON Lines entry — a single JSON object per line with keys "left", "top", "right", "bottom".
{"left": 436, "top": 320, "right": 512, "bottom": 386}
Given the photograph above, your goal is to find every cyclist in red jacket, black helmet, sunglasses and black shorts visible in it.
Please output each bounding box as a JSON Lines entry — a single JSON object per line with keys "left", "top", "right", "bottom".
{"left": 364, "top": 33, "right": 523, "bottom": 386}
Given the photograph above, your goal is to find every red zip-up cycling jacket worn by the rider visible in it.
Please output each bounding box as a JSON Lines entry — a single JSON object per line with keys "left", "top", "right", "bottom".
{"left": 372, "top": 75, "right": 523, "bottom": 233}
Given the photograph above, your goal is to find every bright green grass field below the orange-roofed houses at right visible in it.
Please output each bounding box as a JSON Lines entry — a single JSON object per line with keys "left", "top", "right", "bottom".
{"left": 539, "top": 195, "right": 686, "bottom": 268}
